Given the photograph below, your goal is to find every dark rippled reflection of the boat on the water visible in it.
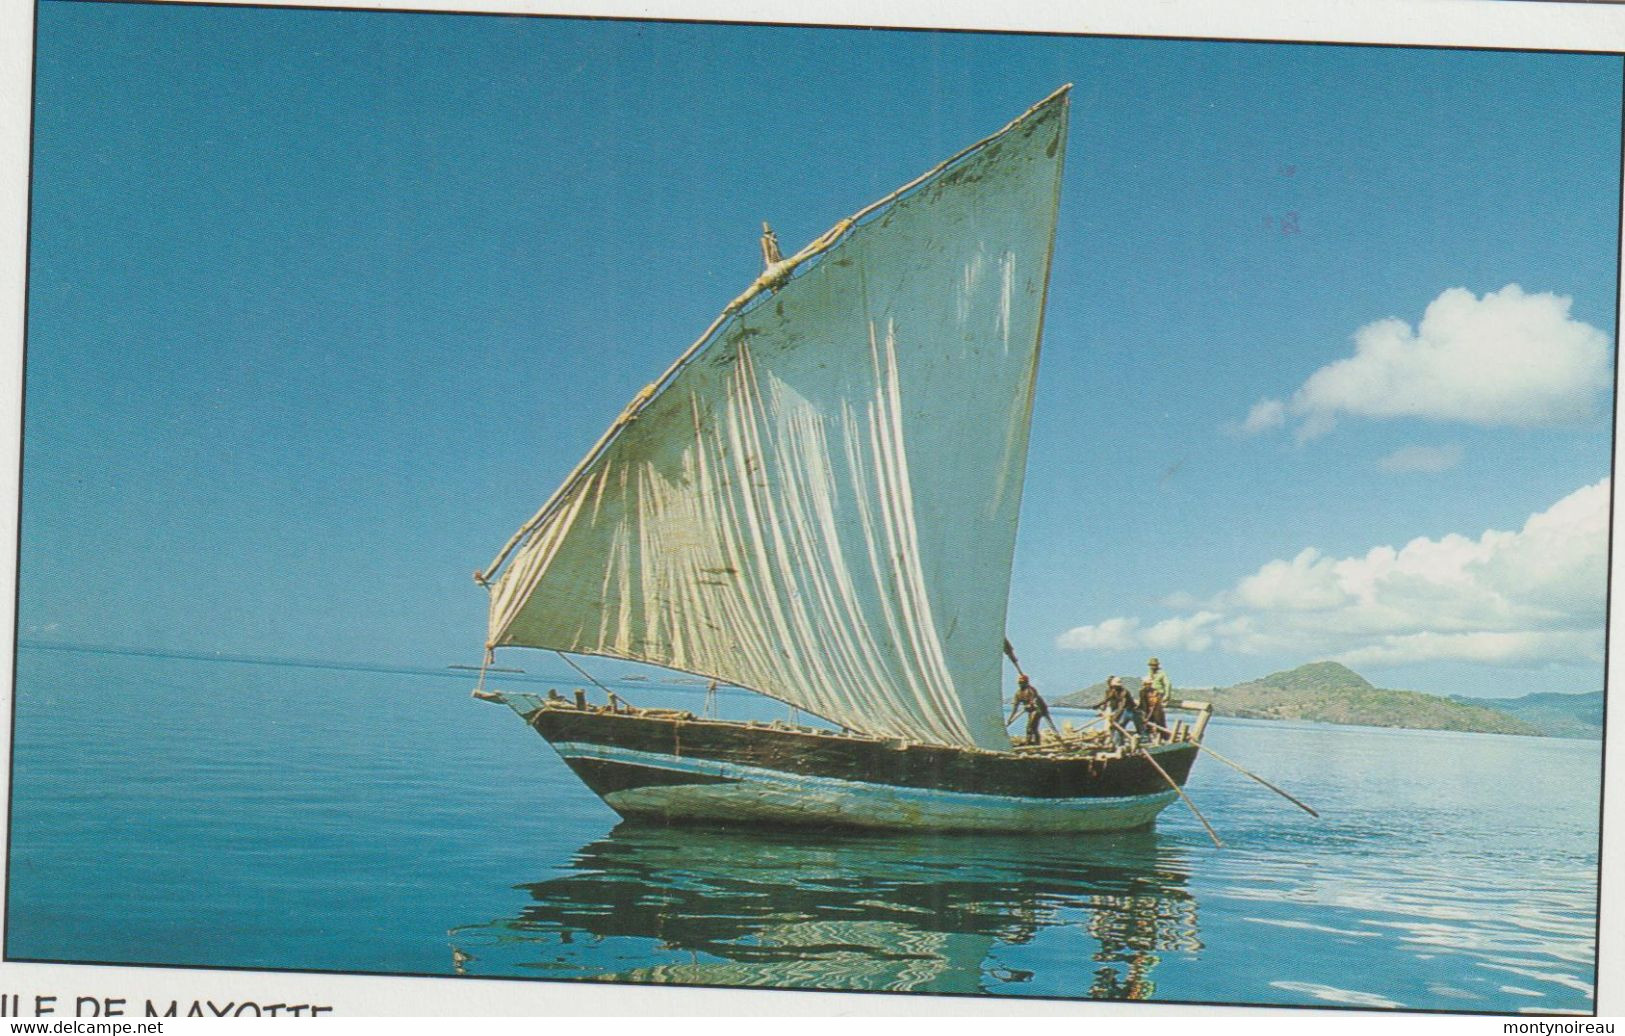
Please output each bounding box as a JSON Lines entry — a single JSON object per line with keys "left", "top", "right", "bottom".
{"left": 450, "top": 825, "right": 1201, "bottom": 1000}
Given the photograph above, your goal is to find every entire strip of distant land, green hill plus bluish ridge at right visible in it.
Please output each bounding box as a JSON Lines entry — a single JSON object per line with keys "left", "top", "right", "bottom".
{"left": 1056, "top": 663, "right": 1602, "bottom": 737}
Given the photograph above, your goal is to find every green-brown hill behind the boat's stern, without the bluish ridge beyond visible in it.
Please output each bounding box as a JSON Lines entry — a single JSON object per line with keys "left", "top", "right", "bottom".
{"left": 1056, "top": 663, "right": 1545, "bottom": 736}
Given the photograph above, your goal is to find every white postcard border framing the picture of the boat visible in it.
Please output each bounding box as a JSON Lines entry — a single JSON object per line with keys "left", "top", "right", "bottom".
{"left": 0, "top": 0, "right": 1625, "bottom": 1033}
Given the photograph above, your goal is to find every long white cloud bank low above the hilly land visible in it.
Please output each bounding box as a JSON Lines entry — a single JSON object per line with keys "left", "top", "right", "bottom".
{"left": 1058, "top": 479, "right": 1610, "bottom": 666}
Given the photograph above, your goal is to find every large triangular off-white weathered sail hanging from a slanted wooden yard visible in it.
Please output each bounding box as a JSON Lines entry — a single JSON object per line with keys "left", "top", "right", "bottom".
{"left": 481, "top": 89, "right": 1066, "bottom": 750}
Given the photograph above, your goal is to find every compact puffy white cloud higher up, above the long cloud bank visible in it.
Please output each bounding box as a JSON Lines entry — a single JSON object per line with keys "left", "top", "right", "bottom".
{"left": 1238, "top": 284, "right": 1612, "bottom": 438}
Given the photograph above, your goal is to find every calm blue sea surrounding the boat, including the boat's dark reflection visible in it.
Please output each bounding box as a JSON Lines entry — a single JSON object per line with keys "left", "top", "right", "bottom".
{"left": 7, "top": 648, "right": 1601, "bottom": 1012}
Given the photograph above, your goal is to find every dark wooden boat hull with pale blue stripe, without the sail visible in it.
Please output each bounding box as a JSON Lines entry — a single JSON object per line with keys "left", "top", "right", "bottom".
{"left": 487, "top": 695, "right": 1196, "bottom": 833}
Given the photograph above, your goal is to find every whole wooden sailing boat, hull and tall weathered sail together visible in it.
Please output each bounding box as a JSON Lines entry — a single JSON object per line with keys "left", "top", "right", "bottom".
{"left": 475, "top": 86, "right": 1201, "bottom": 831}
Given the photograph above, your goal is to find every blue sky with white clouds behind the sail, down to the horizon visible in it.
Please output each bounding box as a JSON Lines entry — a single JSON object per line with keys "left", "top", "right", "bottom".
{"left": 20, "top": 0, "right": 1622, "bottom": 697}
